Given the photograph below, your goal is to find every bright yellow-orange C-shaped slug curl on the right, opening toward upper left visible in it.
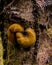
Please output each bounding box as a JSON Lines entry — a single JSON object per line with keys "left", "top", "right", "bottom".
{"left": 16, "top": 28, "right": 36, "bottom": 47}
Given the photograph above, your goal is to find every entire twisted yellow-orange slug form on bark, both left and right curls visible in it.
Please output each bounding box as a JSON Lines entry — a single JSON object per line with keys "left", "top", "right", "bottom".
{"left": 8, "top": 24, "right": 36, "bottom": 48}
